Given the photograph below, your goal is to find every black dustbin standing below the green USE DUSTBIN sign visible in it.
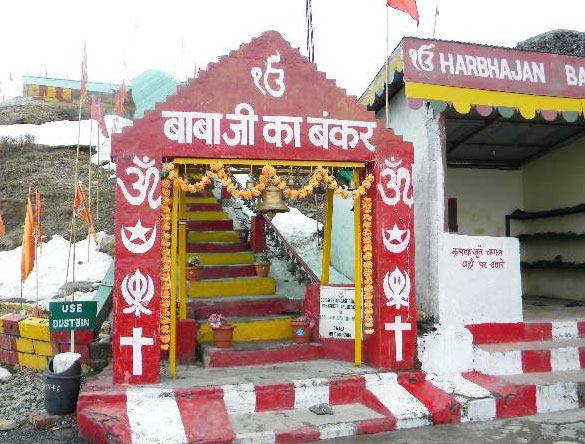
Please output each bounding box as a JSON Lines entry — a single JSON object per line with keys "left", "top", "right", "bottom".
{"left": 43, "top": 358, "right": 81, "bottom": 415}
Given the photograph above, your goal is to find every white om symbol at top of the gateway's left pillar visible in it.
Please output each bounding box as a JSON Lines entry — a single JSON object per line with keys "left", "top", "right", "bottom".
{"left": 117, "top": 156, "right": 160, "bottom": 210}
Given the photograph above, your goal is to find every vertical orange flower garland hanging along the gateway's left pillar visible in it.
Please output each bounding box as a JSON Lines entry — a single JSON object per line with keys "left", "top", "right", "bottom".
{"left": 160, "top": 179, "right": 171, "bottom": 351}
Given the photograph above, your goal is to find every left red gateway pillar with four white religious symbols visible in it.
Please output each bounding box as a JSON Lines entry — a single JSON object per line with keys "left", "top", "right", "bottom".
{"left": 113, "top": 154, "right": 161, "bottom": 384}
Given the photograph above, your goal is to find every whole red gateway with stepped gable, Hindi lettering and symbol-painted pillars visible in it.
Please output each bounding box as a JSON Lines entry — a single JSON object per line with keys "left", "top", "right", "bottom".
{"left": 107, "top": 31, "right": 416, "bottom": 384}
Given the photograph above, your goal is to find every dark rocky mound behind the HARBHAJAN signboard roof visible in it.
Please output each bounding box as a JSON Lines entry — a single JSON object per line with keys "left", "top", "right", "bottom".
{"left": 516, "top": 29, "right": 585, "bottom": 57}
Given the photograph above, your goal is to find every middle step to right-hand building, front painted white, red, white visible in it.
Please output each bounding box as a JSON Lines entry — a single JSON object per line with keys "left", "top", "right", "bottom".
{"left": 473, "top": 338, "right": 585, "bottom": 375}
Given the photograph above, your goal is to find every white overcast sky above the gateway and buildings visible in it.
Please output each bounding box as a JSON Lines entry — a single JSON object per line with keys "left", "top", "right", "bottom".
{"left": 0, "top": 0, "right": 585, "bottom": 96}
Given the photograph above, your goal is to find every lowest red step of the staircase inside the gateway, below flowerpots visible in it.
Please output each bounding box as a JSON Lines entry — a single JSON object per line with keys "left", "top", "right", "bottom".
{"left": 202, "top": 340, "right": 325, "bottom": 367}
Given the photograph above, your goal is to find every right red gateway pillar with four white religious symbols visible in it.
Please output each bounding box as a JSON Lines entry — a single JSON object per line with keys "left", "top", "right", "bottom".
{"left": 364, "top": 151, "right": 417, "bottom": 370}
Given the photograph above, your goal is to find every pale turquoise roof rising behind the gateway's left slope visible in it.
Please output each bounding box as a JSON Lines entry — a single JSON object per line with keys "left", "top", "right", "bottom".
{"left": 132, "top": 69, "right": 184, "bottom": 119}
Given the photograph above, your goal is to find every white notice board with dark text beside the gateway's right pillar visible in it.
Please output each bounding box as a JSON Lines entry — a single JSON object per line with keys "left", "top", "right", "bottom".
{"left": 319, "top": 286, "right": 355, "bottom": 339}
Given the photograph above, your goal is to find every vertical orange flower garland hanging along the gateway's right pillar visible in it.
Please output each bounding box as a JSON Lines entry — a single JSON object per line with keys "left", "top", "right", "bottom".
{"left": 362, "top": 197, "right": 374, "bottom": 335}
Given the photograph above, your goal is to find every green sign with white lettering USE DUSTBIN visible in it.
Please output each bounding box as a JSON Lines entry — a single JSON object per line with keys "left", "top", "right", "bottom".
{"left": 49, "top": 301, "right": 97, "bottom": 331}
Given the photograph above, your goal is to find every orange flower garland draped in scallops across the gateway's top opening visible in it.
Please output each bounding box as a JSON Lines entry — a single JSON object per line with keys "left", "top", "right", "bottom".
{"left": 165, "top": 162, "right": 374, "bottom": 199}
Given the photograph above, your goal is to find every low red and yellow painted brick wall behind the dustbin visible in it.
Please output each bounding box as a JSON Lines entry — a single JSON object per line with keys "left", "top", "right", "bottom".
{"left": 0, "top": 313, "right": 93, "bottom": 370}
